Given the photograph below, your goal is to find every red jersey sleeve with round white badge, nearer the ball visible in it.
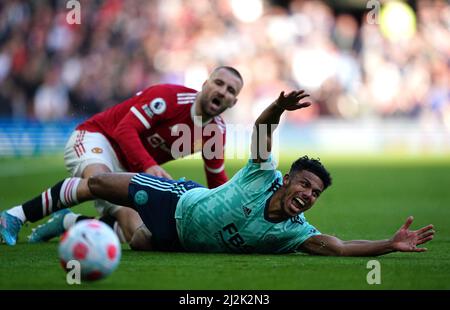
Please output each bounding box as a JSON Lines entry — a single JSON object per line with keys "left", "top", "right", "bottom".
{"left": 113, "top": 86, "right": 176, "bottom": 172}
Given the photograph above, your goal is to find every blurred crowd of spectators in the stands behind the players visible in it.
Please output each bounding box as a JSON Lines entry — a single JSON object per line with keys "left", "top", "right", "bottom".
{"left": 0, "top": 0, "right": 450, "bottom": 128}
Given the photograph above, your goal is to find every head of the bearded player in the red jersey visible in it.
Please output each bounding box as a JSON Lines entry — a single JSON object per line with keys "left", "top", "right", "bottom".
{"left": 200, "top": 69, "right": 242, "bottom": 117}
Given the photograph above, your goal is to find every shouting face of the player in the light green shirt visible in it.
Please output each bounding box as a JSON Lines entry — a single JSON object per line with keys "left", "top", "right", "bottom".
{"left": 281, "top": 170, "right": 323, "bottom": 217}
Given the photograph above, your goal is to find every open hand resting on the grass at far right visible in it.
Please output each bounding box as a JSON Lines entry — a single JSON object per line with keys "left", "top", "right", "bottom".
{"left": 391, "top": 216, "right": 434, "bottom": 252}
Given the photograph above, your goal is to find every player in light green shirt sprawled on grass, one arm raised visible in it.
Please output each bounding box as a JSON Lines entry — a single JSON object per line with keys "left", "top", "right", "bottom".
{"left": 83, "top": 91, "right": 434, "bottom": 256}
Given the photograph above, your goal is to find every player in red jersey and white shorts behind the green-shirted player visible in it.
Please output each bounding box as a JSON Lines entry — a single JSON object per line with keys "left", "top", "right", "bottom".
{"left": 0, "top": 66, "right": 243, "bottom": 245}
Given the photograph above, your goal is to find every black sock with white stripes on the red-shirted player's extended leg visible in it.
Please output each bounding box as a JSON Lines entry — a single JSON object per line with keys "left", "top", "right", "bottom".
{"left": 22, "top": 178, "right": 81, "bottom": 222}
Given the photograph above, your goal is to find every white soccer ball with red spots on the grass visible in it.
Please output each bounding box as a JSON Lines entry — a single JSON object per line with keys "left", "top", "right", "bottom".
{"left": 58, "top": 220, "right": 121, "bottom": 280}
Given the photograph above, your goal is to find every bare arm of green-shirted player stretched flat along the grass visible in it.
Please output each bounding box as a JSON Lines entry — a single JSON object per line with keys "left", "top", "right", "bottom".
{"left": 300, "top": 216, "right": 434, "bottom": 256}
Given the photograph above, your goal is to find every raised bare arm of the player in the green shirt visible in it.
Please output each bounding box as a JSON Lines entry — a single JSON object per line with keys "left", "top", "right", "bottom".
{"left": 251, "top": 90, "right": 311, "bottom": 163}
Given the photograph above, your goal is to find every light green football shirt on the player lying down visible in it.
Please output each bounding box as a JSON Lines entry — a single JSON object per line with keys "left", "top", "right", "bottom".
{"left": 175, "top": 158, "right": 320, "bottom": 253}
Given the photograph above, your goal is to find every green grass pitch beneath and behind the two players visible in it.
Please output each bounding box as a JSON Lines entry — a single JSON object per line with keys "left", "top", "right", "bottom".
{"left": 0, "top": 156, "right": 450, "bottom": 290}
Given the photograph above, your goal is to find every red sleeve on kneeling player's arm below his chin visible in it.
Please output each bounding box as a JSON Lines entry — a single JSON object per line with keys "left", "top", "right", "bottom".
{"left": 202, "top": 120, "right": 228, "bottom": 188}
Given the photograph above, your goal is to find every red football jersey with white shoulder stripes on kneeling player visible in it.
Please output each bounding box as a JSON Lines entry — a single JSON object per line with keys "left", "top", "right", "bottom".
{"left": 77, "top": 84, "right": 228, "bottom": 188}
